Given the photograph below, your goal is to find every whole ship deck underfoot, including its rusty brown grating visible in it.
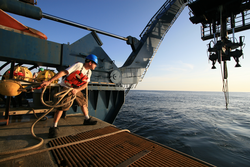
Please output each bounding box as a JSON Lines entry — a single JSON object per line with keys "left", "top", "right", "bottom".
{"left": 0, "top": 114, "right": 213, "bottom": 167}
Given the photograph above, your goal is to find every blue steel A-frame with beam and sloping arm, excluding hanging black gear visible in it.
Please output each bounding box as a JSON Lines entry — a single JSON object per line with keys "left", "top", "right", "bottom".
{"left": 0, "top": 0, "right": 186, "bottom": 123}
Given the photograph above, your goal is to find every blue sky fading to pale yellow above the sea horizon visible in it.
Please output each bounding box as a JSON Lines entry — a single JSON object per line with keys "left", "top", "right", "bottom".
{"left": 3, "top": 0, "right": 250, "bottom": 92}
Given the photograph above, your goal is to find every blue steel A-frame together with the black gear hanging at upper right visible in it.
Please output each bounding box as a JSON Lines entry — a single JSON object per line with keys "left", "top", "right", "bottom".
{"left": 0, "top": 0, "right": 250, "bottom": 123}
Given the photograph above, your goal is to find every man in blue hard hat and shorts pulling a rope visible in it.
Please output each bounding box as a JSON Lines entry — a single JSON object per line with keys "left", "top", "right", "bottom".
{"left": 41, "top": 54, "right": 98, "bottom": 138}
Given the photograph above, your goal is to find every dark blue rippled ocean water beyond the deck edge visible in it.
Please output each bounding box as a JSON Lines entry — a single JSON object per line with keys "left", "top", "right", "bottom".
{"left": 114, "top": 90, "right": 250, "bottom": 167}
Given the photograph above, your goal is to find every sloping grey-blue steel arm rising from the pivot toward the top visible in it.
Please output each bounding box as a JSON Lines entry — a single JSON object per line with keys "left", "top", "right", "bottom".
{"left": 120, "top": 0, "right": 187, "bottom": 87}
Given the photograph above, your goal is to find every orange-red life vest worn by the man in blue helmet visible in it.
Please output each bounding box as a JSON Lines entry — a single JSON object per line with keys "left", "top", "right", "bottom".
{"left": 64, "top": 70, "right": 88, "bottom": 88}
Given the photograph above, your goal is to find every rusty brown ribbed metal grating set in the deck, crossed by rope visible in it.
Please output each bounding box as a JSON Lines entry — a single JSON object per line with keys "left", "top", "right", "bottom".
{"left": 48, "top": 126, "right": 213, "bottom": 167}
